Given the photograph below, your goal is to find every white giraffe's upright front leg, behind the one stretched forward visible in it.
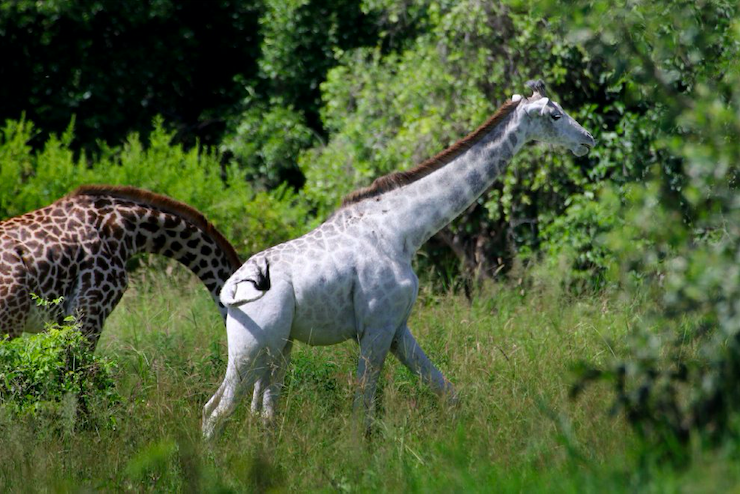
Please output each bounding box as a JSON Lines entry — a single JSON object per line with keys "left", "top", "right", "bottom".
{"left": 354, "top": 329, "right": 393, "bottom": 433}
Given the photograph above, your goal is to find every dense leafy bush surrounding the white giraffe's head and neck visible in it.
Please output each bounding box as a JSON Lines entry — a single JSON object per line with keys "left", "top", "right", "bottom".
{"left": 300, "top": 1, "right": 643, "bottom": 282}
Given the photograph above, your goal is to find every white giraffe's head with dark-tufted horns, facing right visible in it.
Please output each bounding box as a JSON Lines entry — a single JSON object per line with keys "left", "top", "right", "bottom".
{"left": 511, "top": 80, "right": 596, "bottom": 156}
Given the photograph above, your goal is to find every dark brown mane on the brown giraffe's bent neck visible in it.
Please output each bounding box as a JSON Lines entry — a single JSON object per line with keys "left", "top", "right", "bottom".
{"left": 68, "top": 185, "right": 242, "bottom": 270}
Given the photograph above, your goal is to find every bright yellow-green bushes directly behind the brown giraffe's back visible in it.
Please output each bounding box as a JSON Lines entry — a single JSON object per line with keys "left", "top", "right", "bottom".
{"left": 0, "top": 114, "right": 310, "bottom": 256}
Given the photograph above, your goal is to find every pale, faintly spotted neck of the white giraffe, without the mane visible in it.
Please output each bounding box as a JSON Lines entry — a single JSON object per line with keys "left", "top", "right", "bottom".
{"left": 376, "top": 110, "right": 527, "bottom": 256}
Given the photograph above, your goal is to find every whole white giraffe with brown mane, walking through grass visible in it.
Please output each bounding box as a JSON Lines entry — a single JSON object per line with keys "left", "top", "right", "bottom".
{"left": 203, "top": 81, "right": 594, "bottom": 438}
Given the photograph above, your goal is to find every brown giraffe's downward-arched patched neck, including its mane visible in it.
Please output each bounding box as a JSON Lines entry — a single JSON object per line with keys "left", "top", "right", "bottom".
{"left": 70, "top": 186, "right": 241, "bottom": 315}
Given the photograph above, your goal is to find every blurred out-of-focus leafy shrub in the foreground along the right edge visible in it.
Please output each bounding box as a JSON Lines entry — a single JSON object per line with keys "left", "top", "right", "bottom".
{"left": 560, "top": 0, "right": 740, "bottom": 458}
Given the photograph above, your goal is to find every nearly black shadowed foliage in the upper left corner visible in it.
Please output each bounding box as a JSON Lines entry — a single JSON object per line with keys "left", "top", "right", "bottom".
{"left": 0, "top": 0, "right": 261, "bottom": 148}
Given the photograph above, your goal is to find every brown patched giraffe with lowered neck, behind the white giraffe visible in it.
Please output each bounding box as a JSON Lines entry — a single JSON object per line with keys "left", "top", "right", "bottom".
{"left": 0, "top": 185, "right": 241, "bottom": 348}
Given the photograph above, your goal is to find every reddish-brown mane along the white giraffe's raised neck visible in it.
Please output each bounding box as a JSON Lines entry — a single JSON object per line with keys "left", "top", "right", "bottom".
{"left": 340, "top": 100, "right": 521, "bottom": 209}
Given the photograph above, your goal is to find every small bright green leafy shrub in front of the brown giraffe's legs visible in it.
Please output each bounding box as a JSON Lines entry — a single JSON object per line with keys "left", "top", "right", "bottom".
{"left": 0, "top": 304, "right": 120, "bottom": 424}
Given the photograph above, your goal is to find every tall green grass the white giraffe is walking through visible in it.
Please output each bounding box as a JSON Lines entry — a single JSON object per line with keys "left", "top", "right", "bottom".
{"left": 0, "top": 264, "right": 728, "bottom": 493}
